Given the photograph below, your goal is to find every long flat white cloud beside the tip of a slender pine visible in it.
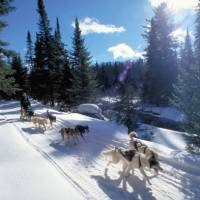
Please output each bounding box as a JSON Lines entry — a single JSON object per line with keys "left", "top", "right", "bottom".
{"left": 72, "top": 17, "right": 126, "bottom": 35}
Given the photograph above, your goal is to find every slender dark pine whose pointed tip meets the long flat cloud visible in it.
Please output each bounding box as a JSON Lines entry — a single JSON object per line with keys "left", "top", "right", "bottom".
{"left": 71, "top": 18, "right": 96, "bottom": 105}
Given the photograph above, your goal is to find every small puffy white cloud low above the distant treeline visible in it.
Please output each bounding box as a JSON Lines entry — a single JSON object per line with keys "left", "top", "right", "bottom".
{"left": 107, "top": 43, "right": 144, "bottom": 59}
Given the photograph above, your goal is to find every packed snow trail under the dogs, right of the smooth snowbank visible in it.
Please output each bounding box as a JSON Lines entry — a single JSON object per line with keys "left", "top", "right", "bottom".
{"left": 0, "top": 102, "right": 200, "bottom": 200}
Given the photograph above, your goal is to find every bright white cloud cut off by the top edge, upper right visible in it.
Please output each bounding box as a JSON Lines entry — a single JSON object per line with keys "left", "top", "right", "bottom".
{"left": 148, "top": 0, "right": 198, "bottom": 10}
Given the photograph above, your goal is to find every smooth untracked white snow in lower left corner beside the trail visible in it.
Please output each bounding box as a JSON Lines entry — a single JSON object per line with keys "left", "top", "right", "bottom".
{"left": 0, "top": 117, "right": 85, "bottom": 200}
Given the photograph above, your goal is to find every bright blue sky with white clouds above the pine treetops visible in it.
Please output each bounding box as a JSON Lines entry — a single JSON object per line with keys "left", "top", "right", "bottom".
{"left": 1, "top": 0, "right": 197, "bottom": 62}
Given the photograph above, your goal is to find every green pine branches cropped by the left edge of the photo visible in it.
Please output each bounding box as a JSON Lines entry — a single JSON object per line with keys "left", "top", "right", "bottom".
{"left": 0, "top": 0, "right": 17, "bottom": 98}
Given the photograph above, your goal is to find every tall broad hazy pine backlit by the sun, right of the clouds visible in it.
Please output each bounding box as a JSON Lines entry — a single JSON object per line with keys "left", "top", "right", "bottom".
{"left": 143, "top": 3, "right": 177, "bottom": 105}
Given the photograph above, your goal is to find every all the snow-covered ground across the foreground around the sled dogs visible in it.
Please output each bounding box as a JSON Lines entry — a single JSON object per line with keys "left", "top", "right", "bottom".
{"left": 0, "top": 101, "right": 200, "bottom": 200}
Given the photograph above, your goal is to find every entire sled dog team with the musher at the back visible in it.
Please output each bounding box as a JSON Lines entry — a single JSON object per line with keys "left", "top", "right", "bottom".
{"left": 20, "top": 93, "right": 163, "bottom": 184}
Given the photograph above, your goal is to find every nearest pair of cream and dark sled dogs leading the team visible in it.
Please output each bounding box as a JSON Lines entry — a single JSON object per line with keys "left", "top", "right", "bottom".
{"left": 102, "top": 132, "right": 163, "bottom": 185}
